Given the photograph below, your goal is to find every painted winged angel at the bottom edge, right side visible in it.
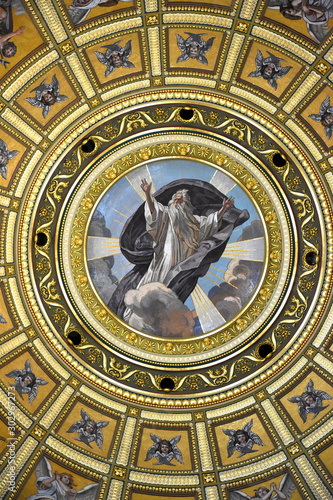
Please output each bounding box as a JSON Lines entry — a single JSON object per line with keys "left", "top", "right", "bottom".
{"left": 229, "top": 473, "right": 296, "bottom": 500}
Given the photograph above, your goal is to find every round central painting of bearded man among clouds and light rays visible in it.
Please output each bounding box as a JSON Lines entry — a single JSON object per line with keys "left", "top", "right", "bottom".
{"left": 86, "top": 159, "right": 267, "bottom": 339}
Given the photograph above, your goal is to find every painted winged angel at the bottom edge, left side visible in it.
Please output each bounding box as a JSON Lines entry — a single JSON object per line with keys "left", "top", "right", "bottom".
{"left": 26, "top": 457, "right": 98, "bottom": 500}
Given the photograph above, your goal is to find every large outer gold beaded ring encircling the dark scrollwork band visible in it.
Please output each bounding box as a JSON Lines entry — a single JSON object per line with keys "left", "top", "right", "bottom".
{"left": 18, "top": 95, "right": 332, "bottom": 408}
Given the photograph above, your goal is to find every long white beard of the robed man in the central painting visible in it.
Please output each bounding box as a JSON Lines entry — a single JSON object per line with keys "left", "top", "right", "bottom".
{"left": 169, "top": 201, "right": 199, "bottom": 250}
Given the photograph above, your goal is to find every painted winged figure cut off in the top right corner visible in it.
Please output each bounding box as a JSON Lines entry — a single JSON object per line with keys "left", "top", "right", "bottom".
{"left": 268, "top": 0, "right": 333, "bottom": 43}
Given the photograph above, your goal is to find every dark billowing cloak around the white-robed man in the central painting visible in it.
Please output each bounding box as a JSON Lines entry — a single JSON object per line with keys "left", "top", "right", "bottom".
{"left": 108, "top": 179, "right": 249, "bottom": 318}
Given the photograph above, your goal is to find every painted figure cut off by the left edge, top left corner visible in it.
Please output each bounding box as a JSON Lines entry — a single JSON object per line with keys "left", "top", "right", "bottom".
{"left": 0, "top": 0, "right": 26, "bottom": 68}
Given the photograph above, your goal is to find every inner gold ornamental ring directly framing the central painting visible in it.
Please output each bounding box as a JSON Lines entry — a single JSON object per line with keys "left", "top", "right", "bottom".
{"left": 66, "top": 138, "right": 290, "bottom": 355}
